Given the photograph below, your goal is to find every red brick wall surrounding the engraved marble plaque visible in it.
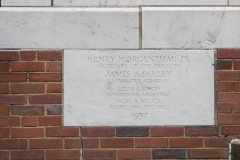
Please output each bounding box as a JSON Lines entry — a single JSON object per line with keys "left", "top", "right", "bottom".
{"left": 0, "top": 49, "right": 240, "bottom": 160}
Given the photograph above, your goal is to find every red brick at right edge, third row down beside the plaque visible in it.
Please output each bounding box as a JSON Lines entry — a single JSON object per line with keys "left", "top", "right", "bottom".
{"left": 217, "top": 71, "right": 240, "bottom": 81}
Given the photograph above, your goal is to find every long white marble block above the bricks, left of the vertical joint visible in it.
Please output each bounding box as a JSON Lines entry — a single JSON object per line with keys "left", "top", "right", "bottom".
{"left": 0, "top": 7, "right": 139, "bottom": 49}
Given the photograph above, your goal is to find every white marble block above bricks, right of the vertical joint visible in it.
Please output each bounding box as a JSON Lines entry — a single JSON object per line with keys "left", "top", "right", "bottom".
{"left": 142, "top": 7, "right": 240, "bottom": 49}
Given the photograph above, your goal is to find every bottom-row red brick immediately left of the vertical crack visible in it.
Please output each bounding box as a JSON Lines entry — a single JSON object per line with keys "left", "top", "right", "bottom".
{"left": 46, "top": 150, "right": 80, "bottom": 160}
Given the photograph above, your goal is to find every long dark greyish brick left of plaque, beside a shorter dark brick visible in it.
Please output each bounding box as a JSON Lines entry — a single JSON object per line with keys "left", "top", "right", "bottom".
{"left": 10, "top": 106, "right": 44, "bottom": 116}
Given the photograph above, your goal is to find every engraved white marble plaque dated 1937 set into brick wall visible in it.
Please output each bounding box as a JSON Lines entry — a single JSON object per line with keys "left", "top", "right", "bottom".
{"left": 64, "top": 50, "right": 215, "bottom": 126}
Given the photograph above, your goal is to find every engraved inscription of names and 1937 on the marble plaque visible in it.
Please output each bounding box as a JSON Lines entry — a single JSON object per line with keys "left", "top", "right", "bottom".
{"left": 87, "top": 55, "right": 191, "bottom": 120}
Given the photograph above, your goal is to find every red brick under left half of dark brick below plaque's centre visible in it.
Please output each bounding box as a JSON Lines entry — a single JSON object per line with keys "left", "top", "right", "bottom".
{"left": 100, "top": 138, "right": 134, "bottom": 148}
